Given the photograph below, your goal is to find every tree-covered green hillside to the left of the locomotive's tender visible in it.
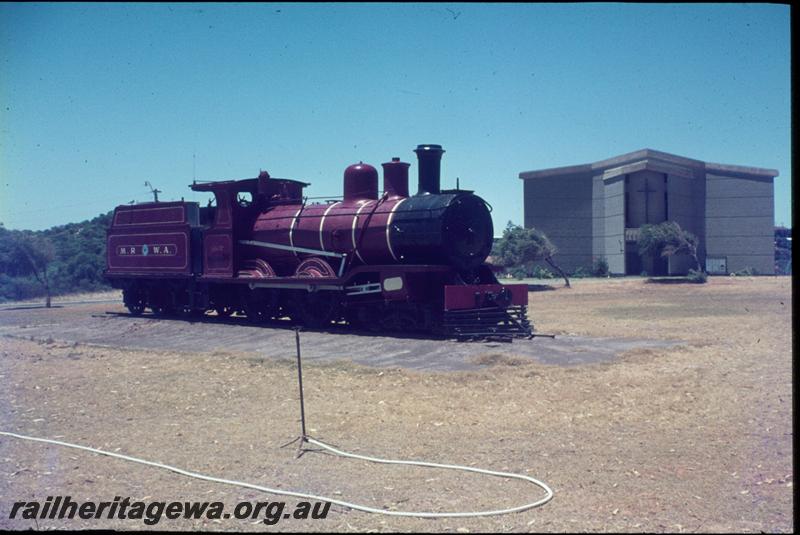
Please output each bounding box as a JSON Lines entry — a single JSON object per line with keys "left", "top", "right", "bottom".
{"left": 0, "top": 212, "right": 111, "bottom": 302}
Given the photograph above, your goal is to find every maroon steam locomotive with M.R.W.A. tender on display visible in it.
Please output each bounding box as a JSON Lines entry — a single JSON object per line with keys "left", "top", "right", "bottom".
{"left": 106, "top": 145, "right": 531, "bottom": 337}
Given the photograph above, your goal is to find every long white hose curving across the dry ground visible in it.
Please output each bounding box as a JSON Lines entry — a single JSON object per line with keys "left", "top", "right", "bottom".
{"left": 0, "top": 431, "right": 553, "bottom": 518}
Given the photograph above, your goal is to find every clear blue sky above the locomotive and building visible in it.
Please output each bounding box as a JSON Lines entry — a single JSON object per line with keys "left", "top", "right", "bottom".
{"left": 0, "top": 3, "right": 791, "bottom": 235}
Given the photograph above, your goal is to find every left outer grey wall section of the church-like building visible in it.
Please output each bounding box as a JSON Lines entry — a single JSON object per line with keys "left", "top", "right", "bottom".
{"left": 524, "top": 174, "right": 592, "bottom": 272}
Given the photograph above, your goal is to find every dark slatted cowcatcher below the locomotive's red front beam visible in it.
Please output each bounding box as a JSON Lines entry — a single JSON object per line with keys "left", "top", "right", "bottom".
{"left": 444, "top": 305, "right": 533, "bottom": 338}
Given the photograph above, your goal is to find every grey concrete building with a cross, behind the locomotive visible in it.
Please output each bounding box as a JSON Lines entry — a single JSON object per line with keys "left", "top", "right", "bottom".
{"left": 519, "top": 149, "right": 778, "bottom": 275}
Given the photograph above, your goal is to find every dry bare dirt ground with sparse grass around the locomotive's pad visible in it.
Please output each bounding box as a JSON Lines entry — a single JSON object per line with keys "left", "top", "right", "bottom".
{"left": 0, "top": 277, "right": 794, "bottom": 532}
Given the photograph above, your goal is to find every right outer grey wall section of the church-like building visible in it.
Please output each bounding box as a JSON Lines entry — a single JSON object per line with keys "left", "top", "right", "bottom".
{"left": 705, "top": 174, "right": 775, "bottom": 274}
